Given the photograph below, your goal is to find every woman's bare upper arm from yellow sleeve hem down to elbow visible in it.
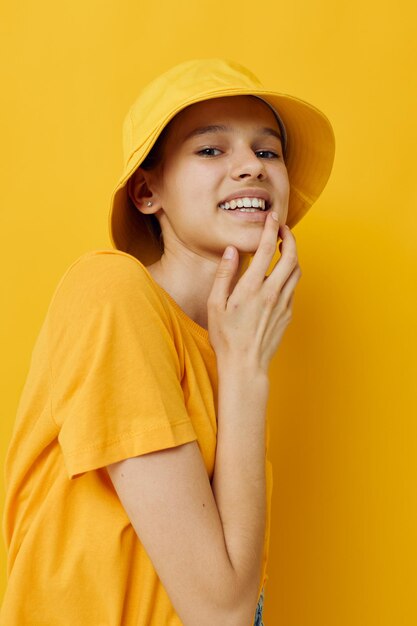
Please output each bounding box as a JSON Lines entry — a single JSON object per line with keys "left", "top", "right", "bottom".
{"left": 107, "top": 441, "right": 245, "bottom": 626}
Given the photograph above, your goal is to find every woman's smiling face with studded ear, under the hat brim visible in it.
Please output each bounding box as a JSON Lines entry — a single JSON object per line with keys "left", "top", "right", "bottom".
{"left": 140, "top": 96, "right": 289, "bottom": 258}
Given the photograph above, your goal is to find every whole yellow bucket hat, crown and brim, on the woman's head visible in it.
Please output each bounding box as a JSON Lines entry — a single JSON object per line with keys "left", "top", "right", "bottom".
{"left": 109, "top": 58, "right": 335, "bottom": 265}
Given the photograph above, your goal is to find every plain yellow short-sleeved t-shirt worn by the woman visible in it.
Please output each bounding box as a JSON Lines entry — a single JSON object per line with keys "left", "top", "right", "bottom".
{"left": 0, "top": 250, "right": 272, "bottom": 626}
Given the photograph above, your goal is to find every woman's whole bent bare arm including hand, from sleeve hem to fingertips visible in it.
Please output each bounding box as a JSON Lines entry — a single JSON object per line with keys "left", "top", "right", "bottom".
{"left": 108, "top": 216, "right": 300, "bottom": 626}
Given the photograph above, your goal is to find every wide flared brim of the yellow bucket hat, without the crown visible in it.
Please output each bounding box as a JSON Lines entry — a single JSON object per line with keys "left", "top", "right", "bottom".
{"left": 109, "top": 88, "right": 335, "bottom": 265}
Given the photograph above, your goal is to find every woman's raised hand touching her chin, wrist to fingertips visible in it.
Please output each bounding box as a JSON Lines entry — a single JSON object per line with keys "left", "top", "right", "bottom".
{"left": 207, "top": 214, "right": 301, "bottom": 373}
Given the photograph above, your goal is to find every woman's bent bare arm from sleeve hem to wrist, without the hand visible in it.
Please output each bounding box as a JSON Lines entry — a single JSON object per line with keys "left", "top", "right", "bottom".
{"left": 107, "top": 368, "right": 267, "bottom": 626}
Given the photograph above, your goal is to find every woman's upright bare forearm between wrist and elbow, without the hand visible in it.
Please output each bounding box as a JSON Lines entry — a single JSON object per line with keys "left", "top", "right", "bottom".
{"left": 212, "top": 358, "right": 269, "bottom": 606}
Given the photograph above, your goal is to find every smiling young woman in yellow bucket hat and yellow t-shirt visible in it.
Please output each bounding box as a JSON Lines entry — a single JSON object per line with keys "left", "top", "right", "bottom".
{"left": 1, "top": 59, "right": 334, "bottom": 626}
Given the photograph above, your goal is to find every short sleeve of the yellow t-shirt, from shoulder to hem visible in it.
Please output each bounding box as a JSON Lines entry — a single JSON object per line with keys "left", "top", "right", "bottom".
{"left": 48, "top": 252, "right": 197, "bottom": 478}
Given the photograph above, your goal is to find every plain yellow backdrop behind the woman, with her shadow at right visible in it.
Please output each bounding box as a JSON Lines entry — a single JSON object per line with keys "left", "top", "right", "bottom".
{"left": 0, "top": 0, "right": 417, "bottom": 626}
